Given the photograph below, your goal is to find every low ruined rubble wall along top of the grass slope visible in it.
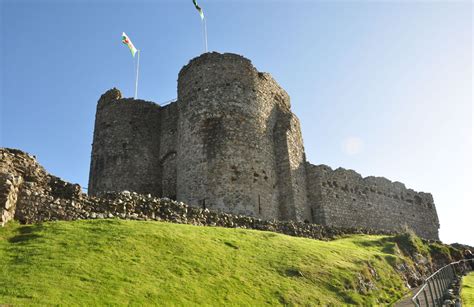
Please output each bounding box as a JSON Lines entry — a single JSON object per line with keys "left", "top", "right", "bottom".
{"left": 0, "top": 148, "right": 396, "bottom": 243}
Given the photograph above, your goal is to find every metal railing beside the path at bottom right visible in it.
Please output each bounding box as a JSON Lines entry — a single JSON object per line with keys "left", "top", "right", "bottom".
{"left": 411, "top": 259, "right": 474, "bottom": 307}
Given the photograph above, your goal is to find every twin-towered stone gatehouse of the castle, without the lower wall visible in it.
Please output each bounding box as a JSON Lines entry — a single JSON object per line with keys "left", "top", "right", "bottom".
{"left": 89, "top": 53, "right": 311, "bottom": 221}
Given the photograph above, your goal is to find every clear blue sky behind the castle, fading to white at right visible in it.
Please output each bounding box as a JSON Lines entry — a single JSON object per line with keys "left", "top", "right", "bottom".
{"left": 0, "top": 0, "right": 474, "bottom": 245}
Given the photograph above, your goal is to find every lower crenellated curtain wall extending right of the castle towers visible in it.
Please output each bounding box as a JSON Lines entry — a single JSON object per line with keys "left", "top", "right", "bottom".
{"left": 307, "top": 163, "right": 439, "bottom": 240}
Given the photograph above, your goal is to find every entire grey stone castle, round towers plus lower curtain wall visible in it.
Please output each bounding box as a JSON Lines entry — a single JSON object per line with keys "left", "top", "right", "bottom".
{"left": 88, "top": 52, "right": 439, "bottom": 239}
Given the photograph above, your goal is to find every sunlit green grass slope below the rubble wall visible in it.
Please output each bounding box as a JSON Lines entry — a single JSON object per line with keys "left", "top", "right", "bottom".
{"left": 0, "top": 220, "right": 412, "bottom": 306}
